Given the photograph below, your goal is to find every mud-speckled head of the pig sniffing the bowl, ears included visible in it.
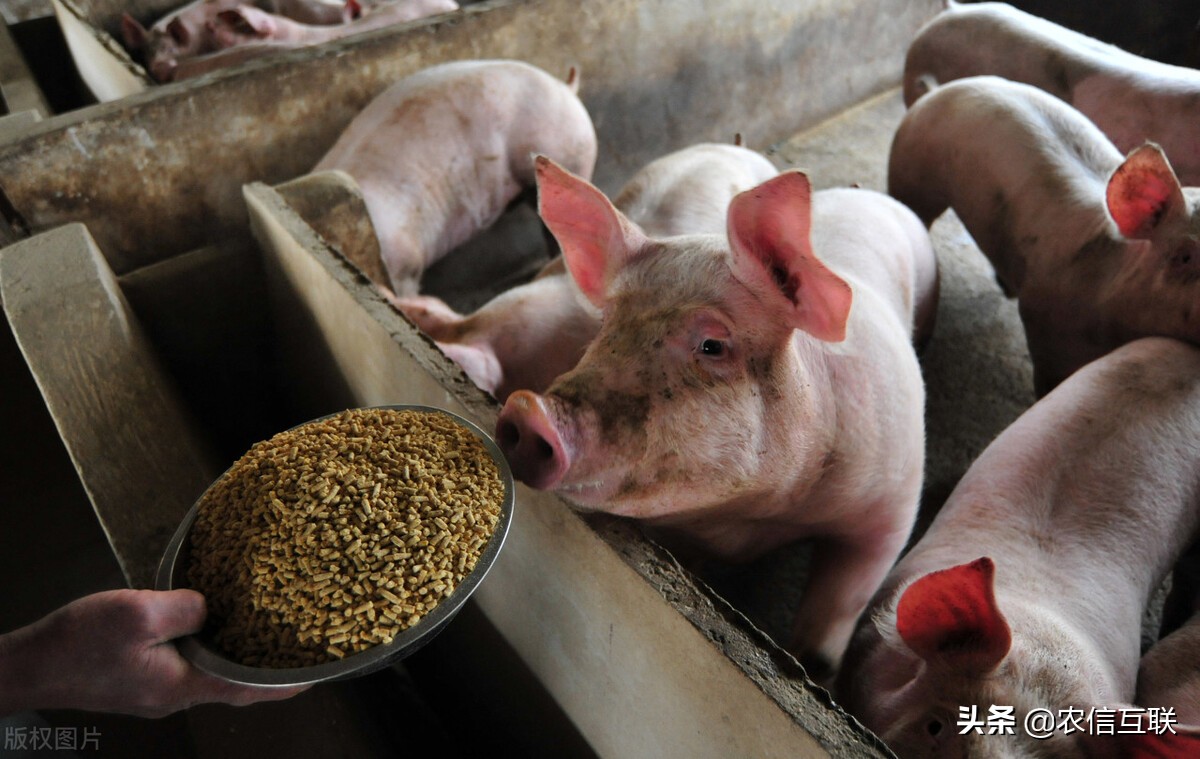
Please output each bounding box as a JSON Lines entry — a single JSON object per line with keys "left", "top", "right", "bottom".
{"left": 497, "top": 153, "right": 851, "bottom": 519}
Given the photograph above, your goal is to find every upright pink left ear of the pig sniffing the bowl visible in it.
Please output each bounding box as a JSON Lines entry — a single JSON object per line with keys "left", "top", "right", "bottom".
{"left": 534, "top": 155, "right": 646, "bottom": 307}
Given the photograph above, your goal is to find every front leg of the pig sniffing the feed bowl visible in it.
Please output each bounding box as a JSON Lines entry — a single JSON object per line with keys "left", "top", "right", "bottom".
{"left": 788, "top": 521, "right": 910, "bottom": 685}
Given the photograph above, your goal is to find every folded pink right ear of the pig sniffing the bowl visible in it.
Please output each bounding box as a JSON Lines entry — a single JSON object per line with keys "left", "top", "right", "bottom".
{"left": 727, "top": 171, "right": 853, "bottom": 342}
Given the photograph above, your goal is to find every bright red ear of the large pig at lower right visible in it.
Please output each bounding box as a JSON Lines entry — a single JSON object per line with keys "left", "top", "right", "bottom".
{"left": 896, "top": 556, "right": 1013, "bottom": 673}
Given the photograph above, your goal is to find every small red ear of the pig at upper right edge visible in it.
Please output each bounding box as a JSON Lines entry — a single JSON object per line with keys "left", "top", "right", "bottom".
{"left": 1106, "top": 143, "right": 1187, "bottom": 240}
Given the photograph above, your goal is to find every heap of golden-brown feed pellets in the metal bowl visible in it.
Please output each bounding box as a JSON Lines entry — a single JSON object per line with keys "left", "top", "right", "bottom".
{"left": 187, "top": 408, "right": 505, "bottom": 668}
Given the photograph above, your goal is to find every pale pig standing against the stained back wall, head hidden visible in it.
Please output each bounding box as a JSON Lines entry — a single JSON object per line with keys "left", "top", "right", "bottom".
{"left": 313, "top": 60, "right": 596, "bottom": 298}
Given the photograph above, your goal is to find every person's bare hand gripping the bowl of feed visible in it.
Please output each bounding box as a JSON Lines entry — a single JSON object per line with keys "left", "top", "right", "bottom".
{"left": 0, "top": 590, "right": 305, "bottom": 717}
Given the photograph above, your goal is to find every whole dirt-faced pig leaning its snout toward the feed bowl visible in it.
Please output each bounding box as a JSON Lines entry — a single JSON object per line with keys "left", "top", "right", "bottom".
{"left": 496, "top": 159, "right": 936, "bottom": 679}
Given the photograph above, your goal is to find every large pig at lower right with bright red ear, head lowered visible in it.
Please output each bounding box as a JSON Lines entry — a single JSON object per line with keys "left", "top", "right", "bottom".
{"left": 835, "top": 337, "right": 1200, "bottom": 758}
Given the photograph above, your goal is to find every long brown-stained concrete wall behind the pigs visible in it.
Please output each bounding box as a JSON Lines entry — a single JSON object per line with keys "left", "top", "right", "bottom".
{"left": 0, "top": 0, "right": 938, "bottom": 274}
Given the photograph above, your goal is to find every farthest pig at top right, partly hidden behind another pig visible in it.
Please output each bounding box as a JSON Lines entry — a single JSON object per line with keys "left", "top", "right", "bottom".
{"left": 904, "top": 2, "right": 1200, "bottom": 185}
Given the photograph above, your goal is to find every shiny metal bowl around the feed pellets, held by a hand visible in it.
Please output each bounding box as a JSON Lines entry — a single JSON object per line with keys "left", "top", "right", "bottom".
{"left": 155, "top": 405, "right": 515, "bottom": 687}
